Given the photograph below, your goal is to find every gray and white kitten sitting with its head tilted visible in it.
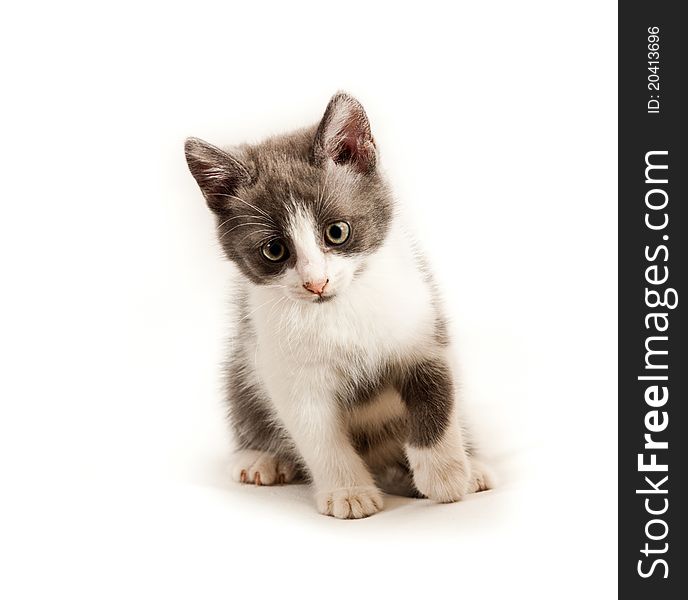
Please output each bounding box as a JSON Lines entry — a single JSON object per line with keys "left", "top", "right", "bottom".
{"left": 185, "top": 93, "right": 491, "bottom": 518}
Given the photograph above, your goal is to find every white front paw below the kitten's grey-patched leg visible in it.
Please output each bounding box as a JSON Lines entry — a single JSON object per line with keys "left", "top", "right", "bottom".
{"left": 408, "top": 448, "right": 475, "bottom": 502}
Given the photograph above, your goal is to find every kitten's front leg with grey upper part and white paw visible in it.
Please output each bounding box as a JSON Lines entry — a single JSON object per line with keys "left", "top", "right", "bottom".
{"left": 399, "top": 359, "right": 476, "bottom": 502}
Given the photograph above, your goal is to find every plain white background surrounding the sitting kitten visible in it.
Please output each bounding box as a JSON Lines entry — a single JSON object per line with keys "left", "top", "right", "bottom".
{"left": 0, "top": 1, "right": 617, "bottom": 599}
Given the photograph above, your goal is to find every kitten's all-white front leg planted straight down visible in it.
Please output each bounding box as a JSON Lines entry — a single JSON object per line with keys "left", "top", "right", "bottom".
{"left": 270, "top": 380, "right": 382, "bottom": 519}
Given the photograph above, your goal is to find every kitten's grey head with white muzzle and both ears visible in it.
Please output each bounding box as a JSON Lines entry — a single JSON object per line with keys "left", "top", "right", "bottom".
{"left": 185, "top": 93, "right": 392, "bottom": 302}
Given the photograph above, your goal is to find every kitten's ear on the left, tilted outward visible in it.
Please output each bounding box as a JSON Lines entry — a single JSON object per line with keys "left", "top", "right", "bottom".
{"left": 184, "top": 138, "right": 251, "bottom": 211}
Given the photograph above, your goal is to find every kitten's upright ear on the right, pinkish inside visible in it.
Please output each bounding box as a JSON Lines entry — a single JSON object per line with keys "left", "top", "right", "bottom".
{"left": 313, "top": 92, "right": 377, "bottom": 173}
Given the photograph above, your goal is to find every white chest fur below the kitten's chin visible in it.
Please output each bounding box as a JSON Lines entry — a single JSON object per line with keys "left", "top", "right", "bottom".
{"left": 249, "top": 223, "right": 435, "bottom": 378}
